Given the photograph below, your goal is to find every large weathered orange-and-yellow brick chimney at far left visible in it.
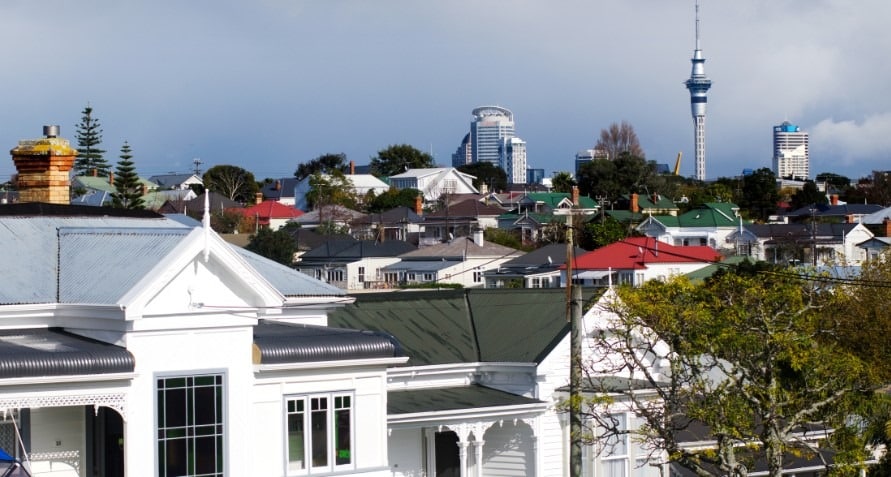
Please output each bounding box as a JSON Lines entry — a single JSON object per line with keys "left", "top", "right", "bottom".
{"left": 9, "top": 126, "right": 77, "bottom": 204}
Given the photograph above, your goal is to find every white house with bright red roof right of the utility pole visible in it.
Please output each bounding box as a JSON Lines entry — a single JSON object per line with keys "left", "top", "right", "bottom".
{"left": 560, "top": 237, "right": 721, "bottom": 286}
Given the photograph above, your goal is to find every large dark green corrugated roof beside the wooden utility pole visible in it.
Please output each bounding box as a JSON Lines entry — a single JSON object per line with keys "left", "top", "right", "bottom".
{"left": 328, "top": 288, "right": 569, "bottom": 366}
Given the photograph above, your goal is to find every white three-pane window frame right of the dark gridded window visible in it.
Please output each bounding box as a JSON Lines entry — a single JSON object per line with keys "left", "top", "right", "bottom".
{"left": 283, "top": 391, "right": 356, "bottom": 476}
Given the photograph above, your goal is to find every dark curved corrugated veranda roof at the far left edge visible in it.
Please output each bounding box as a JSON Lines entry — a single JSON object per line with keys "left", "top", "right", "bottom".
{"left": 0, "top": 328, "right": 134, "bottom": 379}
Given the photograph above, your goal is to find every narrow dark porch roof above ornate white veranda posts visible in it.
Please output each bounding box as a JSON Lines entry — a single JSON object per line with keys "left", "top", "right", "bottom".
{"left": 387, "top": 385, "right": 544, "bottom": 416}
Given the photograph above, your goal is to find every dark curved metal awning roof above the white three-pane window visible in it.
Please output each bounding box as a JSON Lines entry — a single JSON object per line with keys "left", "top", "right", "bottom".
{"left": 254, "top": 321, "right": 403, "bottom": 364}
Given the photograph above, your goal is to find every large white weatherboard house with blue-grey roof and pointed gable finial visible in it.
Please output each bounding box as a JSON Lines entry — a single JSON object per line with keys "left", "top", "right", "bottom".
{"left": 0, "top": 203, "right": 407, "bottom": 477}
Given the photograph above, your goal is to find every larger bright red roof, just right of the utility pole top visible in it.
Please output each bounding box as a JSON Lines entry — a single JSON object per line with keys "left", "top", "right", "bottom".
{"left": 573, "top": 237, "right": 721, "bottom": 270}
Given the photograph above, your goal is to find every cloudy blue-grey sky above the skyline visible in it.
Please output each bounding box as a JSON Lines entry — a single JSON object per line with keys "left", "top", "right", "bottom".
{"left": 0, "top": 0, "right": 891, "bottom": 181}
